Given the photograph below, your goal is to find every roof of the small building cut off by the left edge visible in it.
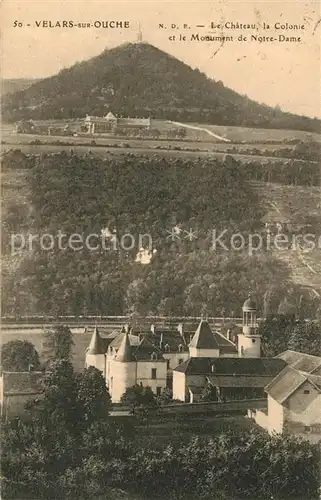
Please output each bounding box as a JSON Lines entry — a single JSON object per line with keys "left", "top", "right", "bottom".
{"left": 2, "top": 371, "right": 44, "bottom": 395}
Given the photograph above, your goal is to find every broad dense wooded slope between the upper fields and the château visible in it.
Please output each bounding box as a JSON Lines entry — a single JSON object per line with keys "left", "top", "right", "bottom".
{"left": 2, "top": 153, "right": 318, "bottom": 316}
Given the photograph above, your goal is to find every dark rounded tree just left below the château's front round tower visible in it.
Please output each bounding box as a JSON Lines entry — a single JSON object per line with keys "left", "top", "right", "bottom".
{"left": 77, "top": 366, "right": 111, "bottom": 427}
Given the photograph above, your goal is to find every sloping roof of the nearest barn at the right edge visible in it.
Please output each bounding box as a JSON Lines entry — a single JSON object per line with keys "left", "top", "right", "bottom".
{"left": 265, "top": 366, "right": 321, "bottom": 404}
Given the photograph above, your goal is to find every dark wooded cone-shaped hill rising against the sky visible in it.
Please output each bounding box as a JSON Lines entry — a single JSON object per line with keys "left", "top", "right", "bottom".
{"left": 2, "top": 43, "right": 320, "bottom": 132}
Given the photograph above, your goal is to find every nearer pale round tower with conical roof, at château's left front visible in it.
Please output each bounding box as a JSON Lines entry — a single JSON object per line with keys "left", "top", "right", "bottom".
{"left": 108, "top": 331, "right": 136, "bottom": 403}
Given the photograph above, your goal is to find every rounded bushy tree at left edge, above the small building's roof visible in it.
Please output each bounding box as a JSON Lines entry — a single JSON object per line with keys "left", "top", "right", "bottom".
{"left": 1, "top": 340, "right": 40, "bottom": 372}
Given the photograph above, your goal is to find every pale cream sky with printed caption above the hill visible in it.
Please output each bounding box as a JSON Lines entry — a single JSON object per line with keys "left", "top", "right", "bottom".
{"left": 0, "top": 0, "right": 321, "bottom": 118}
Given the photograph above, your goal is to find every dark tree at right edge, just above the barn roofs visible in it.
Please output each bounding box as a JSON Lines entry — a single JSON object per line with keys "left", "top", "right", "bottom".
{"left": 289, "top": 320, "right": 321, "bottom": 356}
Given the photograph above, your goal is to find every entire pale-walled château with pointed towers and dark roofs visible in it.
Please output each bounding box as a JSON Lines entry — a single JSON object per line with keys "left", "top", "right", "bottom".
{"left": 86, "top": 297, "right": 285, "bottom": 403}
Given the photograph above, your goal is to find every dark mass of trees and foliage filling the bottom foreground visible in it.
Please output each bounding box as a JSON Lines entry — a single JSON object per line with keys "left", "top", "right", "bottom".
{"left": 1, "top": 360, "right": 320, "bottom": 500}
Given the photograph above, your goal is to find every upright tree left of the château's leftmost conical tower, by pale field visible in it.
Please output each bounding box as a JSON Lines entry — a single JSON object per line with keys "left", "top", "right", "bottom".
{"left": 44, "top": 325, "right": 74, "bottom": 363}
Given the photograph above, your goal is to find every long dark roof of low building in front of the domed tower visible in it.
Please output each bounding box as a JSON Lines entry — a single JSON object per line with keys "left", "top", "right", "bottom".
{"left": 174, "top": 358, "right": 286, "bottom": 377}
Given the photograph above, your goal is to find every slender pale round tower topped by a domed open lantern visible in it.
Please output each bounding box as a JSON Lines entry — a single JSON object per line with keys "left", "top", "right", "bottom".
{"left": 238, "top": 295, "right": 261, "bottom": 358}
